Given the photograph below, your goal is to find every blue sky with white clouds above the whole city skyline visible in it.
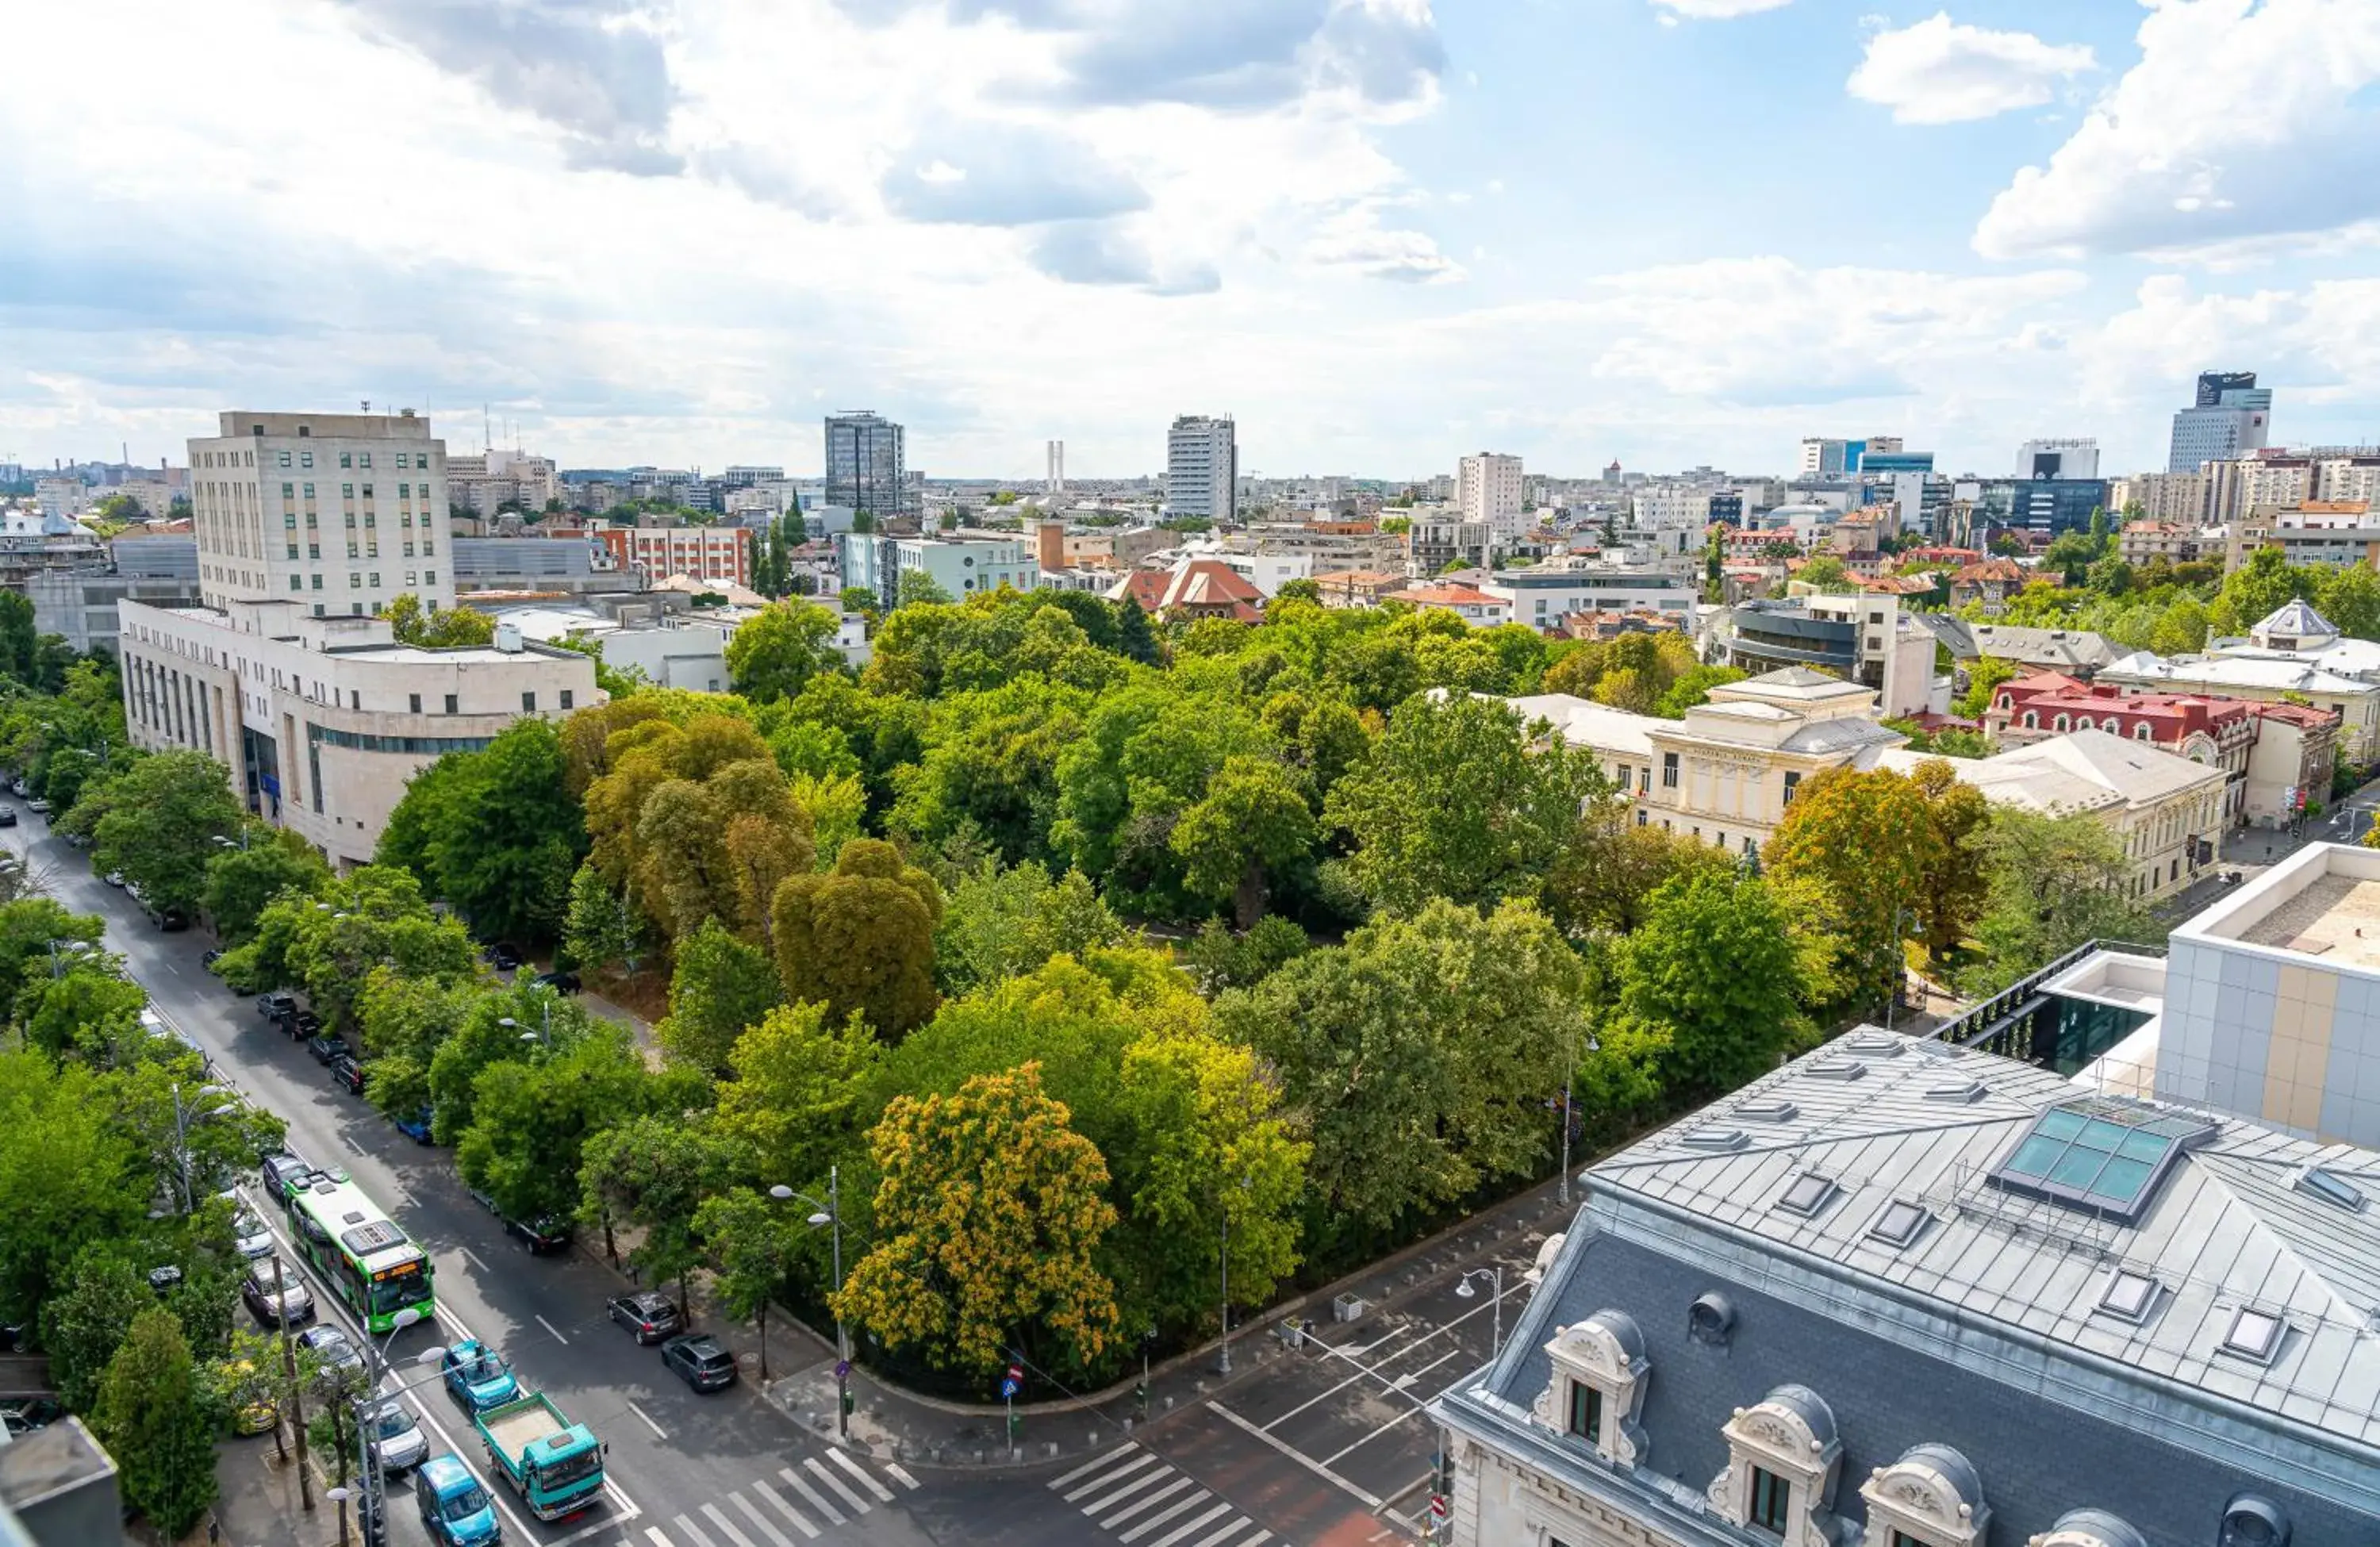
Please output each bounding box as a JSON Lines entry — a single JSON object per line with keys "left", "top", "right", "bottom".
{"left": 0, "top": 0, "right": 2380, "bottom": 478}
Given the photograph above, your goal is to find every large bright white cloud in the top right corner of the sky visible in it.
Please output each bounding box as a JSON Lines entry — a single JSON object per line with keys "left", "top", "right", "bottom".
{"left": 1975, "top": 0, "right": 2380, "bottom": 257}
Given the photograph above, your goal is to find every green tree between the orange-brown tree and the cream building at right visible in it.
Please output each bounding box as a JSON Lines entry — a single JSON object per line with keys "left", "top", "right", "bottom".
{"left": 1961, "top": 807, "right": 2161, "bottom": 995}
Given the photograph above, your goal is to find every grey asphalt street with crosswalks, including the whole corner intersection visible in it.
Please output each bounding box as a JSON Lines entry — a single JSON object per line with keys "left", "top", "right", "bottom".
{"left": 10, "top": 814, "right": 1476, "bottom": 1547}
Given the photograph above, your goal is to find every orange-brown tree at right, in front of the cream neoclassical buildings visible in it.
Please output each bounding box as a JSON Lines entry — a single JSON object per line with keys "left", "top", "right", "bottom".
{"left": 1761, "top": 769, "right": 1942, "bottom": 1000}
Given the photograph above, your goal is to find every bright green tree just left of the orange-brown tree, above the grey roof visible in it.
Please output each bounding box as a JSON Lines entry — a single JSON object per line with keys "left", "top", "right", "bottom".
{"left": 1614, "top": 869, "right": 1806, "bottom": 1097}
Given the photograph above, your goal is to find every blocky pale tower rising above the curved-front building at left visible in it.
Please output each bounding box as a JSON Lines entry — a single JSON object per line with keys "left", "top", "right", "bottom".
{"left": 190, "top": 409, "right": 455, "bottom": 616}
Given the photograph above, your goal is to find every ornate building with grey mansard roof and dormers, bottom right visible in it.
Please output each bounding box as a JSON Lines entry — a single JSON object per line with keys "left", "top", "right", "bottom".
{"left": 1430, "top": 1028, "right": 2380, "bottom": 1547}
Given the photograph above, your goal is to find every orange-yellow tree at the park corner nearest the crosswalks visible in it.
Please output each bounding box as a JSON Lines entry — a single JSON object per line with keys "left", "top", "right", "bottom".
{"left": 833, "top": 1064, "right": 1119, "bottom": 1373}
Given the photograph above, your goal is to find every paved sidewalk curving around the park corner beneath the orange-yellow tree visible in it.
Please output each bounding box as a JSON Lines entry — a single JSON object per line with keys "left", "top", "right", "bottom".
{"left": 752, "top": 1178, "right": 1578, "bottom": 1468}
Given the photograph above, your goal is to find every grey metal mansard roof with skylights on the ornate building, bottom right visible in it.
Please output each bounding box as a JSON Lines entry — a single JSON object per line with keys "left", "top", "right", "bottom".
{"left": 1440, "top": 1031, "right": 2380, "bottom": 1542}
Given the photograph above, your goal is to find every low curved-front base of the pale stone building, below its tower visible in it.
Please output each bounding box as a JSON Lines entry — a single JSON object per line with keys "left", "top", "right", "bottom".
{"left": 117, "top": 593, "right": 605, "bottom": 869}
